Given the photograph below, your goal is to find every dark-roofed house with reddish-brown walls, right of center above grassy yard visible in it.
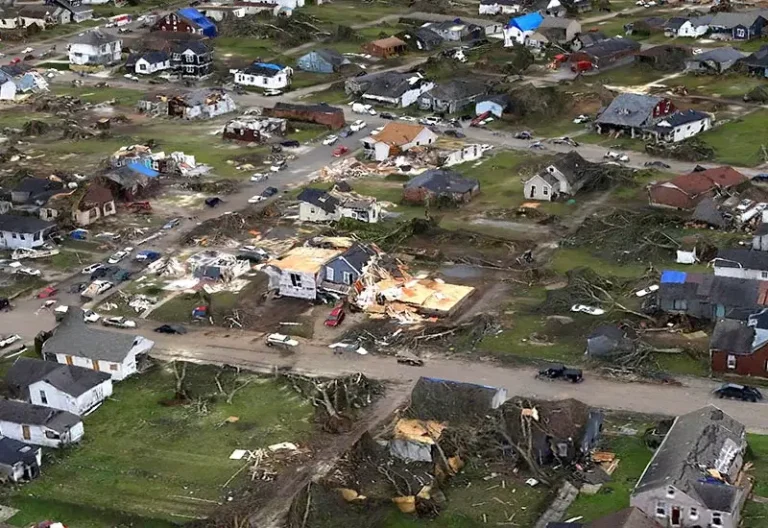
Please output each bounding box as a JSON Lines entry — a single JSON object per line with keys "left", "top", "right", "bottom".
{"left": 403, "top": 169, "right": 480, "bottom": 205}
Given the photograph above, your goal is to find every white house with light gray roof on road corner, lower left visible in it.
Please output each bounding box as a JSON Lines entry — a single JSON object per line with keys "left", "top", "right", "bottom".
{"left": 42, "top": 307, "right": 155, "bottom": 381}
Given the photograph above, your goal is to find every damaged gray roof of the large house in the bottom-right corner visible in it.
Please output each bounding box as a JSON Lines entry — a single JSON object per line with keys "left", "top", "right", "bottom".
{"left": 633, "top": 405, "right": 745, "bottom": 512}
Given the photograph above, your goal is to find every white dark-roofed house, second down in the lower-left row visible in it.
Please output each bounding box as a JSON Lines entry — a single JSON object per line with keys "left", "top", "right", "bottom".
{"left": 5, "top": 357, "right": 112, "bottom": 416}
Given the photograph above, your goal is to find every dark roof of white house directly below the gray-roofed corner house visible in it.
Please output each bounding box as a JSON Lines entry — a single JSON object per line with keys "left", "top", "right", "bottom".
{"left": 5, "top": 357, "right": 112, "bottom": 398}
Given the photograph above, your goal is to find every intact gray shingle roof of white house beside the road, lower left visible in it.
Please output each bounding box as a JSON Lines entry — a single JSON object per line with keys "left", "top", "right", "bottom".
{"left": 43, "top": 306, "right": 144, "bottom": 362}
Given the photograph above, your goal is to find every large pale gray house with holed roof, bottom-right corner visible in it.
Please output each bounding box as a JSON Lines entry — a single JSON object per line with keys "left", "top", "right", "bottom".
{"left": 630, "top": 405, "right": 749, "bottom": 528}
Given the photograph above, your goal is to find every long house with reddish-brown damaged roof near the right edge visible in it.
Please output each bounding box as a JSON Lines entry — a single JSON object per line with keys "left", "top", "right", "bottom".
{"left": 648, "top": 166, "right": 748, "bottom": 209}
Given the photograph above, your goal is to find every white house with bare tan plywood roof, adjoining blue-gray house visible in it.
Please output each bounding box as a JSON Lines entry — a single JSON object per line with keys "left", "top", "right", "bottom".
{"left": 263, "top": 246, "right": 343, "bottom": 299}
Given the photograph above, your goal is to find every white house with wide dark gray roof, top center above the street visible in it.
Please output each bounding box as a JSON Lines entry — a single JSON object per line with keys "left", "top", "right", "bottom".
{"left": 344, "top": 72, "right": 435, "bottom": 108}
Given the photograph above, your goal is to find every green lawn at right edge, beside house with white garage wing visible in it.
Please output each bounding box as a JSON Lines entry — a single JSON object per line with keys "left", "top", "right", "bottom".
{"left": 698, "top": 110, "right": 768, "bottom": 167}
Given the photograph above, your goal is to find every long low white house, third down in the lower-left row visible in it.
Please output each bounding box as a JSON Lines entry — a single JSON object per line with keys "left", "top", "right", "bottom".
{"left": 0, "top": 400, "right": 84, "bottom": 447}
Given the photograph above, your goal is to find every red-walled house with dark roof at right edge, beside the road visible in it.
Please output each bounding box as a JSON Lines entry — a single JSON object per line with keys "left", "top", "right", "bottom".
{"left": 709, "top": 316, "right": 768, "bottom": 378}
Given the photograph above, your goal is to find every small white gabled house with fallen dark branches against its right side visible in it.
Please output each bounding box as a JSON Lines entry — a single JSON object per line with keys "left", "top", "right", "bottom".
{"left": 523, "top": 154, "right": 599, "bottom": 201}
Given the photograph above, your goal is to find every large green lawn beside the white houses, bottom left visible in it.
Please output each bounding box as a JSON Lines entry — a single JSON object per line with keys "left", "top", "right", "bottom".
{"left": 3, "top": 364, "right": 312, "bottom": 528}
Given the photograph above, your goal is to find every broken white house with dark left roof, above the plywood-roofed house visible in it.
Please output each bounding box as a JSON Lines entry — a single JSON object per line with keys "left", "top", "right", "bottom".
{"left": 297, "top": 187, "right": 381, "bottom": 224}
